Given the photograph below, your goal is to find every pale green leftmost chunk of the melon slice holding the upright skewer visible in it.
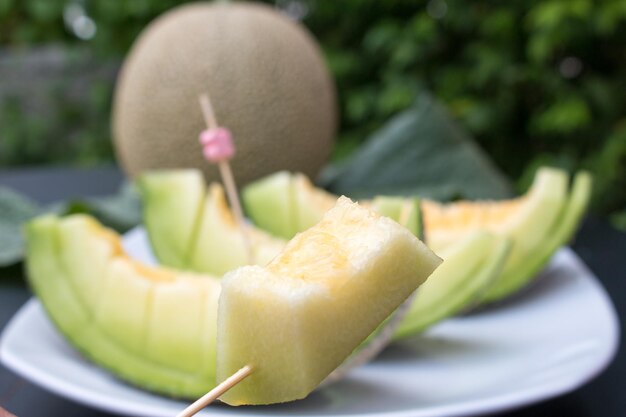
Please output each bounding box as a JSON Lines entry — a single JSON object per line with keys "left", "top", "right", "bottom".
{"left": 137, "top": 169, "right": 206, "bottom": 269}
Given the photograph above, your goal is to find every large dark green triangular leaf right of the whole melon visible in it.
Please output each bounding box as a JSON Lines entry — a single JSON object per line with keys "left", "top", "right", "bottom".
{"left": 320, "top": 94, "right": 511, "bottom": 200}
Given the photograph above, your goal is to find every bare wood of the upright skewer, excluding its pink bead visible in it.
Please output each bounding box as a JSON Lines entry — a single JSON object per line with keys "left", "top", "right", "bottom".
{"left": 200, "top": 93, "right": 254, "bottom": 264}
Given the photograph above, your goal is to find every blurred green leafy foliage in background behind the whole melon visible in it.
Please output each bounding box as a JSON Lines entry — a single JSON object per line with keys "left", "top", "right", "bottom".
{"left": 0, "top": 0, "right": 626, "bottom": 225}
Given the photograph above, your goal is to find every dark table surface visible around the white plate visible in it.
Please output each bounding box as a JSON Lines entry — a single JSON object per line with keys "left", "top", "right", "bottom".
{"left": 0, "top": 167, "right": 626, "bottom": 417}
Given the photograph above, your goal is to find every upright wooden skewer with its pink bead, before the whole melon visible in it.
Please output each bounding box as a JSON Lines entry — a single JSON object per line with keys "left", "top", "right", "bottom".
{"left": 198, "top": 94, "right": 254, "bottom": 264}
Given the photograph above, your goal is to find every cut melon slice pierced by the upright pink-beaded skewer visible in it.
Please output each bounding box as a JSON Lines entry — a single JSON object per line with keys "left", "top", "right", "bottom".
{"left": 138, "top": 170, "right": 286, "bottom": 276}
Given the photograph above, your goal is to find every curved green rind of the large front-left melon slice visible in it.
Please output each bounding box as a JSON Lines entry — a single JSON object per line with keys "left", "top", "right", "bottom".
{"left": 25, "top": 216, "right": 215, "bottom": 398}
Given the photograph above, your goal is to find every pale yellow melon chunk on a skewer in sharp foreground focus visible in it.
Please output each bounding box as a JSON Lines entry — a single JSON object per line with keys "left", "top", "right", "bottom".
{"left": 218, "top": 198, "right": 441, "bottom": 405}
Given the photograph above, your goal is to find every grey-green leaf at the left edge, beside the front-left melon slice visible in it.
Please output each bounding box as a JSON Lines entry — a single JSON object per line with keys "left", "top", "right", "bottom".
{"left": 0, "top": 187, "right": 40, "bottom": 266}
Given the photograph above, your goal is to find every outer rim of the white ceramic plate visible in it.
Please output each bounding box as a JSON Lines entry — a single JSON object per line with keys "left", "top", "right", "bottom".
{"left": 0, "top": 248, "right": 620, "bottom": 417}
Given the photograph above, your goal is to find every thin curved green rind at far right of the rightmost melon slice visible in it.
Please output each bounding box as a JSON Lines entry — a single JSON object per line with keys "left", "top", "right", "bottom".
{"left": 483, "top": 172, "right": 592, "bottom": 302}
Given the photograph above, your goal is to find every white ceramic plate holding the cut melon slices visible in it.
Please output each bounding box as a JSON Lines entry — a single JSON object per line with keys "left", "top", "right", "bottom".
{"left": 0, "top": 231, "right": 618, "bottom": 417}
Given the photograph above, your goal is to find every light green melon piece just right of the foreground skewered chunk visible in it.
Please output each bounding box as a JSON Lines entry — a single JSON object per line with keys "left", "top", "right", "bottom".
{"left": 394, "top": 231, "right": 511, "bottom": 340}
